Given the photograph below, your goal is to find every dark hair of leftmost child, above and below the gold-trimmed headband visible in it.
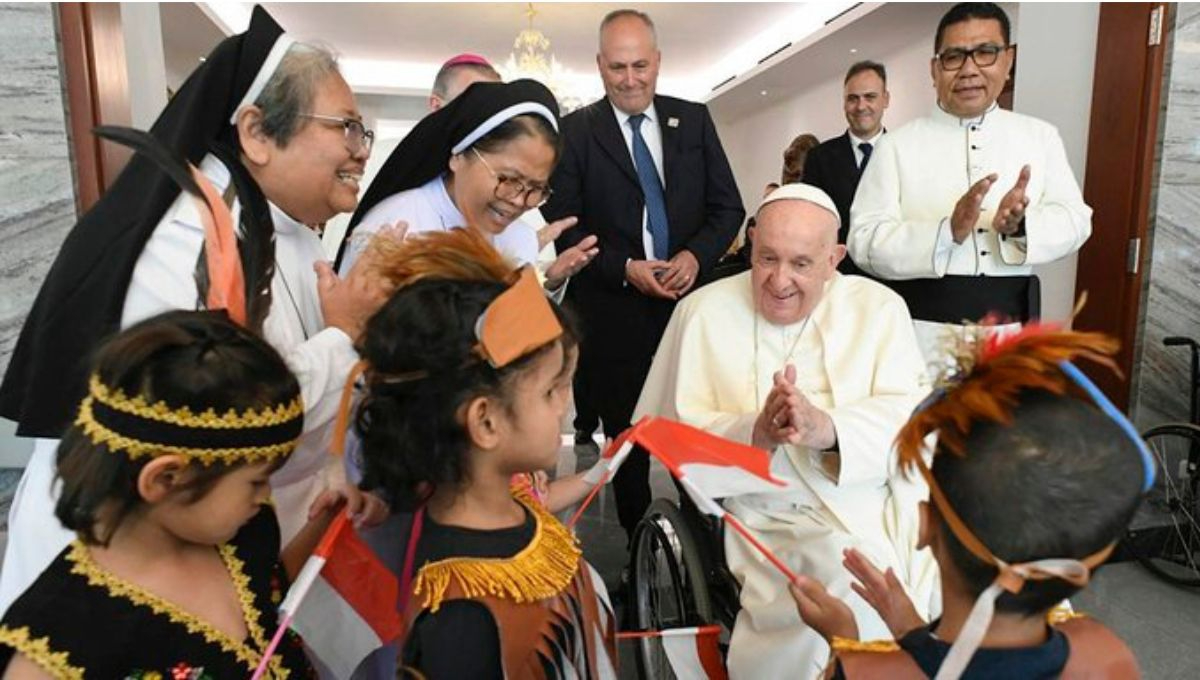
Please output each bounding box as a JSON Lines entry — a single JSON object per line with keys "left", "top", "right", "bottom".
{"left": 55, "top": 311, "right": 300, "bottom": 544}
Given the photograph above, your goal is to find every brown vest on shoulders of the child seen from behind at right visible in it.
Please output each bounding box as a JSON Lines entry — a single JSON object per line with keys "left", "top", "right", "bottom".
{"left": 836, "top": 616, "right": 1141, "bottom": 680}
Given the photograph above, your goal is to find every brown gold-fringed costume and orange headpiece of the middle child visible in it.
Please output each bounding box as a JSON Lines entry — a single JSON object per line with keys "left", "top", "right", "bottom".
{"left": 355, "top": 262, "right": 617, "bottom": 679}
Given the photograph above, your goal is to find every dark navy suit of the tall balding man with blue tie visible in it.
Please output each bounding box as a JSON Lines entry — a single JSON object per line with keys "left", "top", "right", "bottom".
{"left": 541, "top": 96, "right": 745, "bottom": 359}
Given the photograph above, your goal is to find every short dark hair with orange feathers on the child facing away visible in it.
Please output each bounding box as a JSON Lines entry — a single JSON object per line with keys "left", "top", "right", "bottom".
{"left": 896, "top": 326, "right": 1146, "bottom": 615}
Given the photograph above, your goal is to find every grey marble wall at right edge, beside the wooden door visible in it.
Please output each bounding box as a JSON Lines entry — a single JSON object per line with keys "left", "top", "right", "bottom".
{"left": 1135, "top": 2, "right": 1200, "bottom": 427}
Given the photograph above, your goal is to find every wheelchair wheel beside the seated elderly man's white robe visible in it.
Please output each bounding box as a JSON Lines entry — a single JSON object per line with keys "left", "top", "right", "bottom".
{"left": 630, "top": 498, "right": 713, "bottom": 680}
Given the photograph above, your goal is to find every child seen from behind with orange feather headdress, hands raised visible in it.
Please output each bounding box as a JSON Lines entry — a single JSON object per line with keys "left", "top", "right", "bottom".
{"left": 792, "top": 326, "right": 1154, "bottom": 680}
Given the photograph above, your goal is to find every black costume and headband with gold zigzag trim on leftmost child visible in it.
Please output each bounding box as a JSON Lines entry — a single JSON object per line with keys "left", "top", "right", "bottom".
{"left": 0, "top": 359, "right": 312, "bottom": 680}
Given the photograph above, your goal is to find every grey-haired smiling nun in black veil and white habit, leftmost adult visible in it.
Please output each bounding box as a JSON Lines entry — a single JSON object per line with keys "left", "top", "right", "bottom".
{"left": 0, "top": 7, "right": 382, "bottom": 610}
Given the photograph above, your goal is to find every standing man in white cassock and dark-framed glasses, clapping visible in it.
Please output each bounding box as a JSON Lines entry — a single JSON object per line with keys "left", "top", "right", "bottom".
{"left": 846, "top": 4, "right": 1092, "bottom": 372}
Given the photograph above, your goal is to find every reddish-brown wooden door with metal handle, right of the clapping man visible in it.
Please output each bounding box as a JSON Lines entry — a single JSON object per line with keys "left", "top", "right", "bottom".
{"left": 1074, "top": 2, "right": 1174, "bottom": 410}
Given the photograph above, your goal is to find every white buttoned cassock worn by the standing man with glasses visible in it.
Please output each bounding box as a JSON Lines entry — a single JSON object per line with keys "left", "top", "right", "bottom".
{"left": 846, "top": 106, "right": 1092, "bottom": 374}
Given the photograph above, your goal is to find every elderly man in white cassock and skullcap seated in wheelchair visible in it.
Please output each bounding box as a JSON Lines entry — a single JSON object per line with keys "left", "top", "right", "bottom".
{"left": 635, "top": 185, "right": 938, "bottom": 679}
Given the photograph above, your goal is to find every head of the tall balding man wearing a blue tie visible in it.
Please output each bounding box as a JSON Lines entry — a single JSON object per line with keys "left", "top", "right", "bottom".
{"left": 596, "top": 17, "right": 661, "bottom": 115}
